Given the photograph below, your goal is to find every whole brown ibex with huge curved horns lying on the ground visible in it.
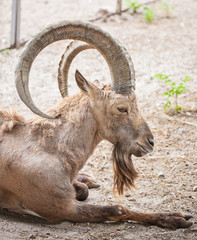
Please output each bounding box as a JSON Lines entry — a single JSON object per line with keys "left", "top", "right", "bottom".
{"left": 0, "top": 21, "right": 192, "bottom": 228}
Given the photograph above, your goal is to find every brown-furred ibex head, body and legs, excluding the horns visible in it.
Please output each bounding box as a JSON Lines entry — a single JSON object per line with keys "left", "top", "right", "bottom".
{"left": 0, "top": 71, "right": 191, "bottom": 228}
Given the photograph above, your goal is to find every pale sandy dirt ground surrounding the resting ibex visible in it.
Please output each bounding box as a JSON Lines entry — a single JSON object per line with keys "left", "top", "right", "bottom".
{"left": 0, "top": 0, "right": 197, "bottom": 240}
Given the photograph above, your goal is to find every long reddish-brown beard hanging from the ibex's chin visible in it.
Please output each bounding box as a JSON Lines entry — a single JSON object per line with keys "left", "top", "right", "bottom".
{"left": 112, "top": 143, "right": 138, "bottom": 196}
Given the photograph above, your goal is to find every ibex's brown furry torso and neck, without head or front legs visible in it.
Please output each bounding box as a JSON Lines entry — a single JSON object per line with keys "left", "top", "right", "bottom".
{"left": 0, "top": 93, "right": 97, "bottom": 216}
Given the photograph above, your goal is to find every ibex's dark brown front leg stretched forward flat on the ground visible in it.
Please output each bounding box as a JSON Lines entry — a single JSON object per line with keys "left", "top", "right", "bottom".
{"left": 68, "top": 203, "right": 192, "bottom": 229}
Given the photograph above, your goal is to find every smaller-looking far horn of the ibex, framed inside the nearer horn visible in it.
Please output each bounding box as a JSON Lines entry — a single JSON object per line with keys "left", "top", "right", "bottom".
{"left": 57, "top": 41, "right": 94, "bottom": 98}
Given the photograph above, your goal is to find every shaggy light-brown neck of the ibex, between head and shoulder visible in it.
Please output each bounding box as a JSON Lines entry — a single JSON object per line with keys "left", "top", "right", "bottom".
{"left": 30, "top": 94, "right": 102, "bottom": 179}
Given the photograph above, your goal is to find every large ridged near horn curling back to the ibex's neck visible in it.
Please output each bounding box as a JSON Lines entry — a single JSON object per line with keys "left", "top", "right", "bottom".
{"left": 15, "top": 21, "right": 135, "bottom": 118}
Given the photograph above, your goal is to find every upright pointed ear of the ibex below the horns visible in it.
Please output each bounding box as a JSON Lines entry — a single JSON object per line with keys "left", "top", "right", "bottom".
{"left": 75, "top": 70, "right": 100, "bottom": 97}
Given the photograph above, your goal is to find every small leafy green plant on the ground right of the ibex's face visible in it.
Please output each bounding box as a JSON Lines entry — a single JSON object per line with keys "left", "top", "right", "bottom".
{"left": 152, "top": 74, "right": 191, "bottom": 114}
